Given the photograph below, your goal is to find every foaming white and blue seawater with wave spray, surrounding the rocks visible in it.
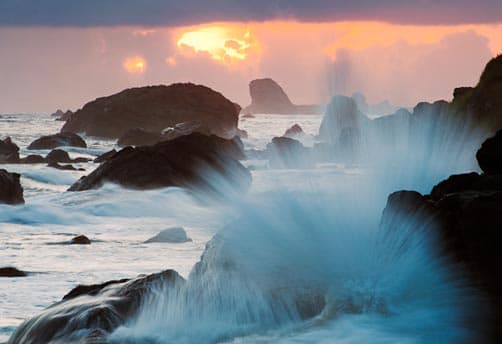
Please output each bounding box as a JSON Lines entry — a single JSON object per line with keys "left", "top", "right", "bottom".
{"left": 0, "top": 115, "right": 483, "bottom": 344}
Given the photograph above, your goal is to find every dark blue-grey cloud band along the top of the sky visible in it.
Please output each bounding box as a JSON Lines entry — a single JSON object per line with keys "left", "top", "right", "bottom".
{"left": 0, "top": 0, "right": 502, "bottom": 27}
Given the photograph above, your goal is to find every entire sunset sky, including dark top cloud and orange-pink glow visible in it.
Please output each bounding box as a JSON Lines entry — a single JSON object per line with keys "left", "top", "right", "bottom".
{"left": 0, "top": 0, "right": 502, "bottom": 113}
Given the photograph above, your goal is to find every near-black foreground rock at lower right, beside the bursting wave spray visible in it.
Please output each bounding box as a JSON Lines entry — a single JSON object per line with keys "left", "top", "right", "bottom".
{"left": 382, "top": 134, "right": 502, "bottom": 343}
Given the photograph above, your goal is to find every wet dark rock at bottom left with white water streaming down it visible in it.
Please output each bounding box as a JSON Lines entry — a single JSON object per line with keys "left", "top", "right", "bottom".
{"left": 9, "top": 270, "right": 185, "bottom": 344}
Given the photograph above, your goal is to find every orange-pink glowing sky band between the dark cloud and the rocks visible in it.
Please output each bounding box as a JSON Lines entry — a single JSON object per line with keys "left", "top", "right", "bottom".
{"left": 0, "top": 21, "right": 502, "bottom": 112}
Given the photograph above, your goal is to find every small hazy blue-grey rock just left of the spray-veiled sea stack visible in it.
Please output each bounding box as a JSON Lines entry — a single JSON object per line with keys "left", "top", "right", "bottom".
{"left": 266, "top": 137, "right": 315, "bottom": 168}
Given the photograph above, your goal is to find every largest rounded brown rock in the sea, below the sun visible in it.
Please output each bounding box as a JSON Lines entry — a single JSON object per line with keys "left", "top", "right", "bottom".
{"left": 61, "top": 83, "right": 239, "bottom": 138}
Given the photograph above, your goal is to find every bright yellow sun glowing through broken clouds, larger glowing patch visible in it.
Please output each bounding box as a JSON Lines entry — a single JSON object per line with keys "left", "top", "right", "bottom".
{"left": 177, "top": 25, "right": 257, "bottom": 63}
